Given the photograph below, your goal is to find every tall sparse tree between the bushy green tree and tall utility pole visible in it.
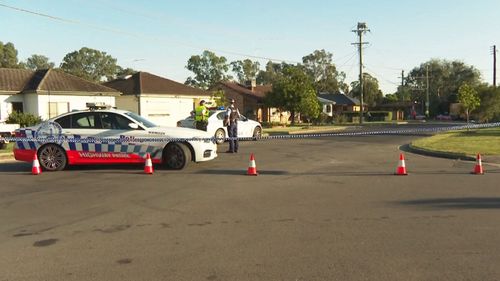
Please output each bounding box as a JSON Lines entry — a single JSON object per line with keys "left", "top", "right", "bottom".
{"left": 302, "top": 49, "right": 345, "bottom": 93}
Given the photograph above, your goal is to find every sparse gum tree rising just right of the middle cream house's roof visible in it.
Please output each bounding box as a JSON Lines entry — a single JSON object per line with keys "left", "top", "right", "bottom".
{"left": 184, "top": 50, "right": 232, "bottom": 90}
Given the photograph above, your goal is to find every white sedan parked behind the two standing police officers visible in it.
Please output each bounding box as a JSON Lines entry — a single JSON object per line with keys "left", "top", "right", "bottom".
{"left": 177, "top": 110, "right": 262, "bottom": 144}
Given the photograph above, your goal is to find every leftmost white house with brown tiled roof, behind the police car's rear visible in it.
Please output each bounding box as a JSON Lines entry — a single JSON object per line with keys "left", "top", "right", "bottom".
{"left": 0, "top": 68, "right": 120, "bottom": 121}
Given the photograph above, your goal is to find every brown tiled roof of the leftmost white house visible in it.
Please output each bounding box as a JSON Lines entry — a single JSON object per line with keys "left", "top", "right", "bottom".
{"left": 0, "top": 68, "right": 120, "bottom": 95}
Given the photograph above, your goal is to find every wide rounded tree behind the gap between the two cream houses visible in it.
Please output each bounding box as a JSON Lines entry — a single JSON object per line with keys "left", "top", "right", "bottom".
{"left": 61, "top": 47, "right": 121, "bottom": 83}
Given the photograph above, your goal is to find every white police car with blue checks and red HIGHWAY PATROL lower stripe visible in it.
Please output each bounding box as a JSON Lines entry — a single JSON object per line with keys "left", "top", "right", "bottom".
{"left": 14, "top": 104, "right": 217, "bottom": 171}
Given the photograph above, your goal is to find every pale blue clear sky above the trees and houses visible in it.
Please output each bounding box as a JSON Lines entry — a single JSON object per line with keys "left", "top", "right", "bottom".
{"left": 0, "top": 0, "right": 500, "bottom": 94}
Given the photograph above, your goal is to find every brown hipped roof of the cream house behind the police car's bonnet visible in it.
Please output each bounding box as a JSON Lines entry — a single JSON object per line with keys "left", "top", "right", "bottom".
{"left": 104, "top": 72, "right": 211, "bottom": 96}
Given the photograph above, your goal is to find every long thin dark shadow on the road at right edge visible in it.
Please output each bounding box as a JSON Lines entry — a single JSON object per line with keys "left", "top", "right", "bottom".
{"left": 398, "top": 197, "right": 500, "bottom": 209}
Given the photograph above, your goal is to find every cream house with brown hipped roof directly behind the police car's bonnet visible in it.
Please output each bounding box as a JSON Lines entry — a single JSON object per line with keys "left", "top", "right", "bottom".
{"left": 104, "top": 72, "right": 212, "bottom": 126}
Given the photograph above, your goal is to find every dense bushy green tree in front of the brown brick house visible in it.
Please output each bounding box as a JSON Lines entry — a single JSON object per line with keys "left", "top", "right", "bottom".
{"left": 264, "top": 66, "right": 320, "bottom": 124}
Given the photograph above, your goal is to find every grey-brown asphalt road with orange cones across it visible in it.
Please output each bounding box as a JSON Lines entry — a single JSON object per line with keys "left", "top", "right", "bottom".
{"left": 0, "top": 136, "right": 500, "bottom": 281}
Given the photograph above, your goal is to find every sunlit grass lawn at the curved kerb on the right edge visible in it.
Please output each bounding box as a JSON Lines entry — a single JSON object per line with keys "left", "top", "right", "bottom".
{"left": 412, "top": 128, "right": 500, "bottom": 155}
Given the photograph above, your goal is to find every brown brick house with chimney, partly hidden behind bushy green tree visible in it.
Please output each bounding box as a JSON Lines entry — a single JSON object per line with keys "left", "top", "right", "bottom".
{"left": 212, "top": 80, "right": 290, "bottom": 123}
